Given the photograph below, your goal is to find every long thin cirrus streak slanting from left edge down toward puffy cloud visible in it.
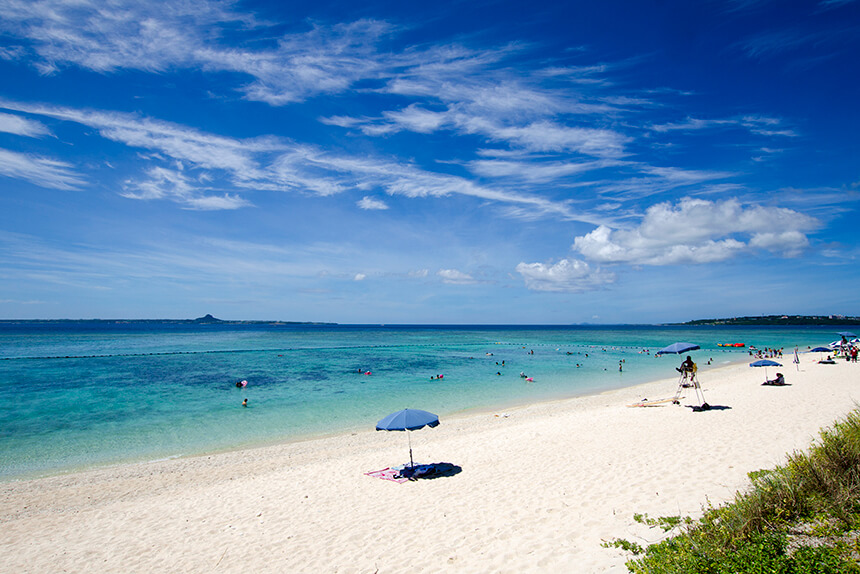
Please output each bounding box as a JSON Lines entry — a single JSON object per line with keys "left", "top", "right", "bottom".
{"left": 0, "top": 101, "right": 590, "bottom": 220}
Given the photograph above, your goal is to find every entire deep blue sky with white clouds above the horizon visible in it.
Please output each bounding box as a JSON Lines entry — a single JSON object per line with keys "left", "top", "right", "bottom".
{"left": 0, "top": 0, "right": 860, "bottom": 324}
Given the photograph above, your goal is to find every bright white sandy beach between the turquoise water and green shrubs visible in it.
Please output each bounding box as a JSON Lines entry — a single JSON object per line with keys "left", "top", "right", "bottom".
{"left": 0, "top": 356, "right": 860, "bottom": 574}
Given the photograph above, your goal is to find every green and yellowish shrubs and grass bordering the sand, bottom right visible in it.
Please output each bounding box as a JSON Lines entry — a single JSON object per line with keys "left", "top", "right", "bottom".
{"left": 604, "top": 410, "right": 860, "bottom": 574}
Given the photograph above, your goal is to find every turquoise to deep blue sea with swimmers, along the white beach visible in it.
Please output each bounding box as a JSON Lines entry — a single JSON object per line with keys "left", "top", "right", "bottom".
{"left": 0, "top": 322, "right": 842, "bottom": 480}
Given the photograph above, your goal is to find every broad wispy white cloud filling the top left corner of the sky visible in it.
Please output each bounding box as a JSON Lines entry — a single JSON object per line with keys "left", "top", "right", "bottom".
{"left": 0, "top": 0, "right": 398, "bottom": 105}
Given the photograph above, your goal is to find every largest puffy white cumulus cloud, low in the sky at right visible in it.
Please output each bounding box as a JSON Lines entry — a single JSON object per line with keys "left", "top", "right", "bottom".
{"left": 573, "top": 198, "right": 818, "bottom": 265}
